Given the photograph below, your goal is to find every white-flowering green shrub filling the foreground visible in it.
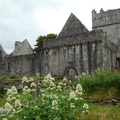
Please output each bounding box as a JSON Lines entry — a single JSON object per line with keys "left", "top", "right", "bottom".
{"left": 0, "top": 74, "right": 89, "bottom": 120}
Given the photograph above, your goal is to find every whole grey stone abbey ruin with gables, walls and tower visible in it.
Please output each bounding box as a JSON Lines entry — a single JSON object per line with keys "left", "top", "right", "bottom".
{"left": 0, "top": 9, "right": 120, "bottom": 77}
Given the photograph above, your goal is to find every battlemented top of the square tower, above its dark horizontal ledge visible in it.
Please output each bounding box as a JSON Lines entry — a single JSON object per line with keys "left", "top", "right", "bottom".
{"left": 92, "top": 8, "right": 120, "bottom": 29}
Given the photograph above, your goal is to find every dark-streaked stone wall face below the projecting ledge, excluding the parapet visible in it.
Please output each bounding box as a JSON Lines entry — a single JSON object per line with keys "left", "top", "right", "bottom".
{"left": 41, "top": 41, "right": 117, "bottom": 77}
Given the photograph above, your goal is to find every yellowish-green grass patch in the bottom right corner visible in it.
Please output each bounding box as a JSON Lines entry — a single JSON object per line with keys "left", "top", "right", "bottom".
{"left": 80, "top": 104, "right": 120, "bottom": 120}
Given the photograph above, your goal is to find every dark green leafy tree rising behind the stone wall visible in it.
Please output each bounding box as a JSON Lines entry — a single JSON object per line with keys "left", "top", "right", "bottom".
{"left": 34, "top": 33, "right": 57, "bottom": 53}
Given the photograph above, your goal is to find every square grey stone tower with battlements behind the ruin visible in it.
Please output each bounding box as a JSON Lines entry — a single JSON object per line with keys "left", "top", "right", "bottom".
{"left": 92, "top": 9, "right": 120, "bottom": 44}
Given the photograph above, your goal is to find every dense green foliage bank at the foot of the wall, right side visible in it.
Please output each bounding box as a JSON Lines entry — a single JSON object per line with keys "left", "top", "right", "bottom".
{"left": 79, "top": 70, "right": 120, "bottom": 93}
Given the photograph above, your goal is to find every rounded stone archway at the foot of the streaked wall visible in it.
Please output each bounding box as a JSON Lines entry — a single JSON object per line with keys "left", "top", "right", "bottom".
{"left": 64, "top": 67, "right": 78, "bottom": 80}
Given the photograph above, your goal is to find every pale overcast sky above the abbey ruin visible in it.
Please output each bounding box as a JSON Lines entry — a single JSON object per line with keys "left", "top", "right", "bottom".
{"left": 0, "top": 0, "right": 120, "bottom": 54}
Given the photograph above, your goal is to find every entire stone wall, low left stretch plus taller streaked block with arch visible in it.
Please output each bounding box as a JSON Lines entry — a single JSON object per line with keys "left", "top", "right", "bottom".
{"left": 0, "top": 30, "right": 117, "bottom": 78}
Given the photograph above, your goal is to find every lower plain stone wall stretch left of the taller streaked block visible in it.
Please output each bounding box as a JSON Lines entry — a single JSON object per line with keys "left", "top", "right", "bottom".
{"left": 0, "top": 53, "right": 41, "bottom": 76}
